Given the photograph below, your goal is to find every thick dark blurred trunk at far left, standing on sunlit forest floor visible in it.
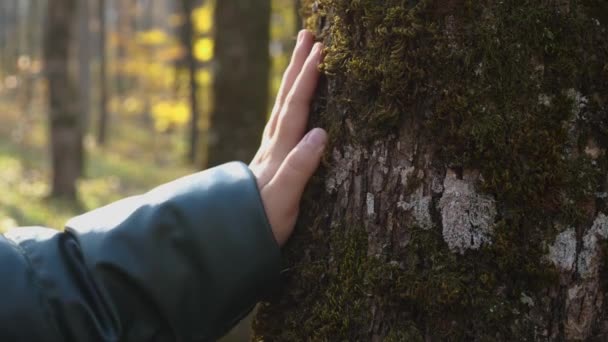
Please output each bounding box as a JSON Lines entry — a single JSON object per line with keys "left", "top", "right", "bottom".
{"left": 44, "top": 0, "right": 82, "bottom": 200}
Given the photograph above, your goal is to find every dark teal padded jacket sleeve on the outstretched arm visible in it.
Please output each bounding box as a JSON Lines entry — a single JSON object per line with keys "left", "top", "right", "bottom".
{"left": 0, "top": 163, "right": 280, "bottom": 341}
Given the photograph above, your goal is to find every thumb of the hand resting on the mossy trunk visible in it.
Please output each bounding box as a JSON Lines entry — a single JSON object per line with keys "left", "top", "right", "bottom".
{"left": 263, "top": 128, "right": 327, "bottom": 243}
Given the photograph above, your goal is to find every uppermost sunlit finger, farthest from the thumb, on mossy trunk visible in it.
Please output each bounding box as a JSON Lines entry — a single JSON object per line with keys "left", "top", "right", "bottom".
{"left": 266, "top": 30, "right": 313, "bottom": 137}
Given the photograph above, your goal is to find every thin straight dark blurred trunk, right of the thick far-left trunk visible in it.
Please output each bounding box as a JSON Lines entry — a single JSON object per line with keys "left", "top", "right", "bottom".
{"left": 97, "top": 0, "right": 109, "bottom": 146}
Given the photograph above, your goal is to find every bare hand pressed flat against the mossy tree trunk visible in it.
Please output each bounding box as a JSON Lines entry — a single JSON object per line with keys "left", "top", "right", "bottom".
{"left": 249, "top": 31, "right": 327, "bottom": 246}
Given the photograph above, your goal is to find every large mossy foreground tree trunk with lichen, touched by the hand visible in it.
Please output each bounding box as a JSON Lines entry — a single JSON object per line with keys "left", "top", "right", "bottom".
{"left": 256, "top": 0, "right": 608, "bottom": 341}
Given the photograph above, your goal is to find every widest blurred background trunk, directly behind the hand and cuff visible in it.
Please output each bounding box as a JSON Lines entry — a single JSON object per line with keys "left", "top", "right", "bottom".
{"left": 207, "top": 0, "right": 270, "bottom": 166}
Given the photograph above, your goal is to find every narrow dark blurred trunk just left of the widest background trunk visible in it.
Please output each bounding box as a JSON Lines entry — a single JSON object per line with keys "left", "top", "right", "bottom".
{"left": 181, "top": 0, "right": 200, "bottom": 164}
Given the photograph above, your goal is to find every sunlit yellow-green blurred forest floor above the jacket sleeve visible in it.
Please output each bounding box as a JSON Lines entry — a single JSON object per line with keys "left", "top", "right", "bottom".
{"left": 0, "top": 98, "right": 195, "bottom": 232}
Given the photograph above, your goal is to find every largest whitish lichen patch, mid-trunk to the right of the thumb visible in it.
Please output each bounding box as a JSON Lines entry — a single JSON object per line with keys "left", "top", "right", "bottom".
{"left": 439, "top": 170, "right": 496, "bottom": 254}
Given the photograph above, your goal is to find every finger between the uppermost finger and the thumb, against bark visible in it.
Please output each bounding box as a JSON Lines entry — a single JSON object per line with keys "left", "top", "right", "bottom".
{"left": 276, "top": 43, "right": 323, "bottom": 155}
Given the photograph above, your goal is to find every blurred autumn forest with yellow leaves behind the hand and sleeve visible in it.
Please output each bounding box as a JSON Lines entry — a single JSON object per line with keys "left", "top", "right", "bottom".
{"left": 0, "top": 0, "right": 300, "bottom": 231}
